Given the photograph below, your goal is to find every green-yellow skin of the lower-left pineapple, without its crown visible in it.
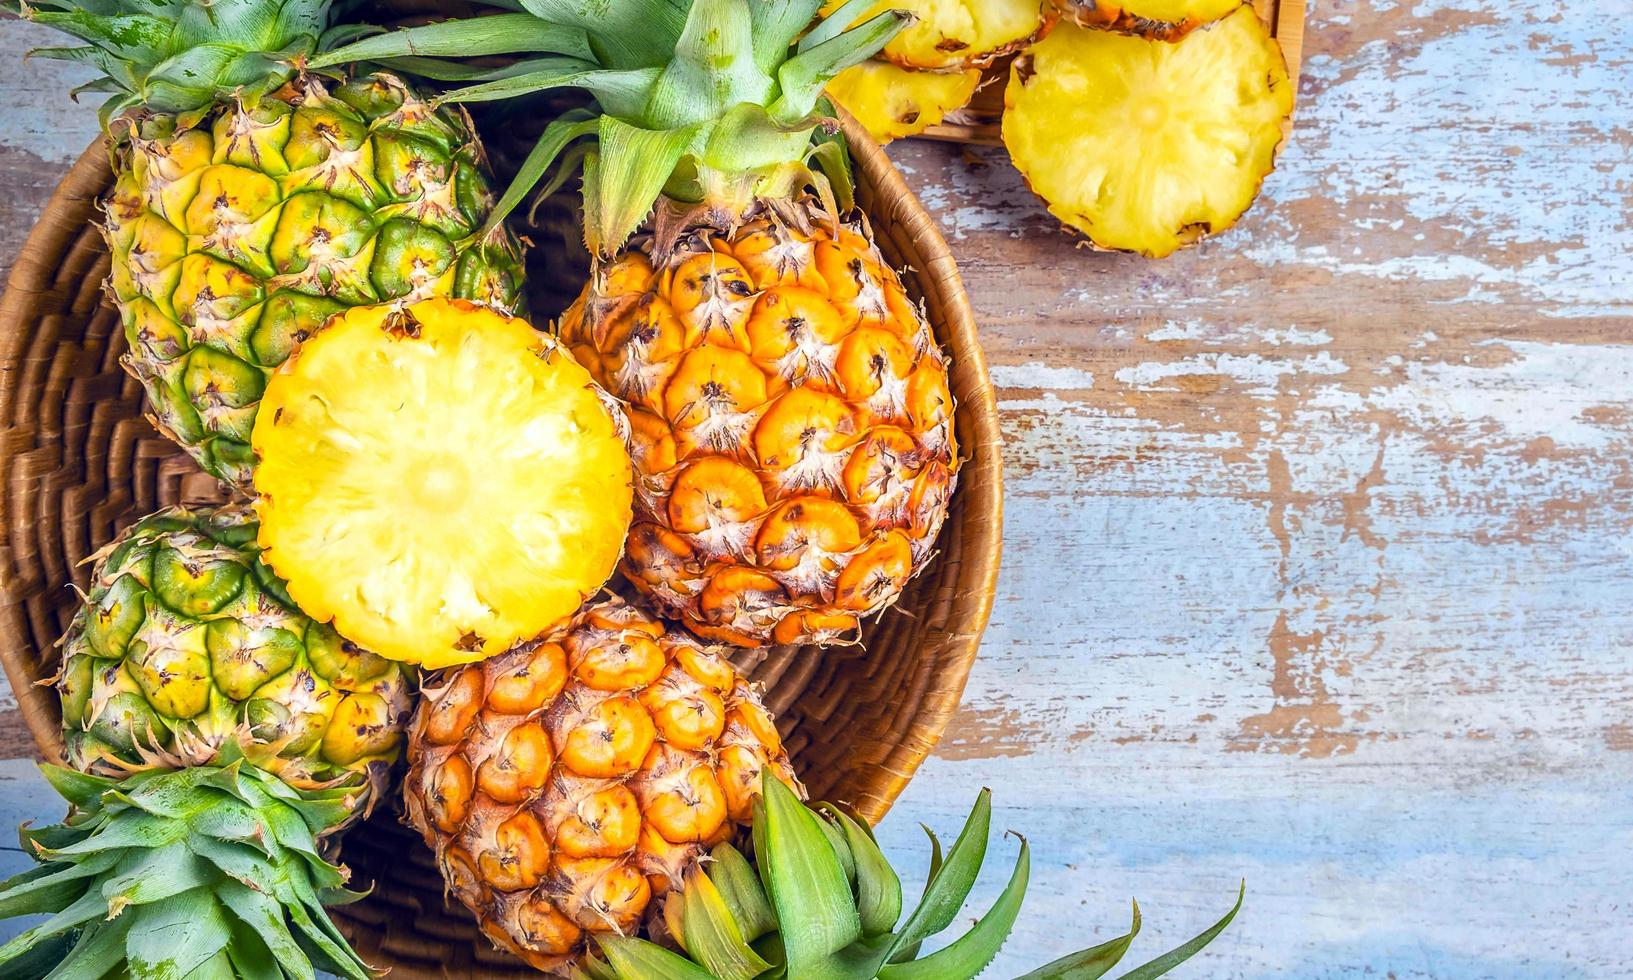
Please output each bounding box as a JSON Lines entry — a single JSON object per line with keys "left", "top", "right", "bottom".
{"left": 57, "top": 506, "right": 413, "bottom": 793}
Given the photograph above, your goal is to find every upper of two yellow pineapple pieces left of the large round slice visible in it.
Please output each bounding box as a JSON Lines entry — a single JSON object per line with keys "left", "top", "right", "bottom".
{"left": 823, "top": 0, "right": 1052, "bottom": 69}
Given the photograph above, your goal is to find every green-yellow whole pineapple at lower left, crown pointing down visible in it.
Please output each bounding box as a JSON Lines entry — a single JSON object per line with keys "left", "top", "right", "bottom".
{"left": 0, "top": 508, "right": 412, "bottom": 980}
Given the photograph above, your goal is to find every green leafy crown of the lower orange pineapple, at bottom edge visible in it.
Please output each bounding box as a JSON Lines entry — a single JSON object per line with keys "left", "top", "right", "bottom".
{"left": 576, "top": 773, "right": 1243, "bottom": 980}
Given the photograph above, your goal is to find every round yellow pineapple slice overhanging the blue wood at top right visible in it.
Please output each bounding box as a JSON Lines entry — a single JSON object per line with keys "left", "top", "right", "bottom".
{"left": 1003, "top": 7, "right": 1293, "bottom": 258}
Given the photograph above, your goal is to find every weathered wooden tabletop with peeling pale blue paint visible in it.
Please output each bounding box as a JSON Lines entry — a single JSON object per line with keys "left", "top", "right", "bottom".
{"left": 0, "top": 0, "right": 1633, "bottom": 980}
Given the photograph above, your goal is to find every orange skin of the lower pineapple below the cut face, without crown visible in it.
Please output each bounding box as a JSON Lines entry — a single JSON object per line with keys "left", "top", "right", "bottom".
{"left": 403, "top": 598, "right": 799, "bottom": 970}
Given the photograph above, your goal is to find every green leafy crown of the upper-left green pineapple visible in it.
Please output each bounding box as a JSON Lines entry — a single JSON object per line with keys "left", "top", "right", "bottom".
{"left": 0, "top": 0, "right": 342, "bottom": 127}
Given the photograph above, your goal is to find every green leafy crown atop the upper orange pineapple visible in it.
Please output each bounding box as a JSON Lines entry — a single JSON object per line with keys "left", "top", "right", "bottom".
{"left": 312, "top": 0, "right": 910, "bottom": 255}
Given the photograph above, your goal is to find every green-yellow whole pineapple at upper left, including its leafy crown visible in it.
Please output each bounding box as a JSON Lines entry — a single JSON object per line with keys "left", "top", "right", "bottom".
{"left": 12, "top": 0, "right": 521, "bottom": 488}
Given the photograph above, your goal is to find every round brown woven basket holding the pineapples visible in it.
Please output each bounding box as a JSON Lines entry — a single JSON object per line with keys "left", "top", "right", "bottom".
{"left": 0, "top": 121, "right": 1003, "bottom": 980}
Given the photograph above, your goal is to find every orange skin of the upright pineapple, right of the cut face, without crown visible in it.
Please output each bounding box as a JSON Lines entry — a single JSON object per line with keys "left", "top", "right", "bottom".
{"left": 562, "top": 201, "right": 959, "bottom": 647}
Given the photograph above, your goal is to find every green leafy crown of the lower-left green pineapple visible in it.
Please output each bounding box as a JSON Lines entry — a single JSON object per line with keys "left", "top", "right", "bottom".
{"left": 0, "top": 751, "right": 372, "bottom": 980}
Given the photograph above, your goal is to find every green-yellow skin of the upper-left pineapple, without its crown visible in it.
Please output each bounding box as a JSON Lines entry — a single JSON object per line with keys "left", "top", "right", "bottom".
{"left": 105, "top": 74, "right": 523, "bottom": 488}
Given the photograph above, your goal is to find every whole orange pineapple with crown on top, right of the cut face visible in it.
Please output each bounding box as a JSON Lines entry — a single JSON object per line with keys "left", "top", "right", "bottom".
{"left": 370, "top": 0, "right": 959, "bottom": 645}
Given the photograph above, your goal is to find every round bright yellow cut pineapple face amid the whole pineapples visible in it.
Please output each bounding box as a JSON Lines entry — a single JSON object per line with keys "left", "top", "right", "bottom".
{"left": 251, "top": 299, "right": 632, "bottom": 666}
